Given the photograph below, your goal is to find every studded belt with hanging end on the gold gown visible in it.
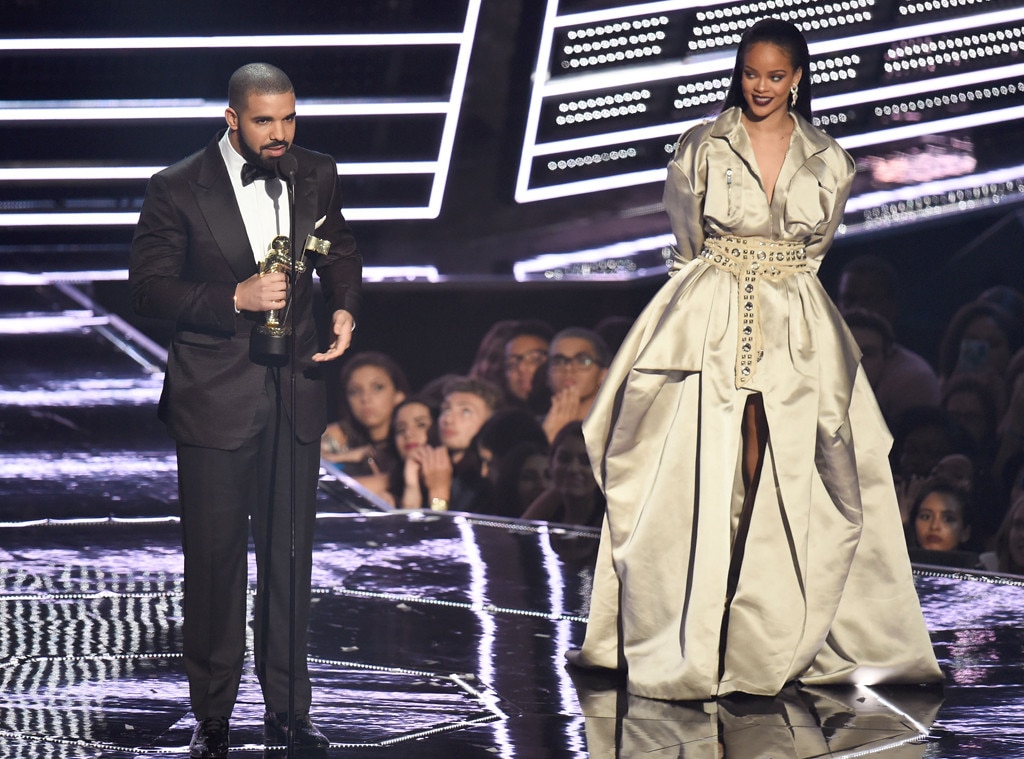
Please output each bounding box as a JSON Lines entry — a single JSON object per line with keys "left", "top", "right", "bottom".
{"left": 700, "top": 237, "right": 810, "bottom": 387}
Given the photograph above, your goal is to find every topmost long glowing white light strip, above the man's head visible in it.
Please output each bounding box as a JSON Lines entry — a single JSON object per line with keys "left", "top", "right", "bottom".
{"left": 0, "top": 32, "right": 463, "bottom": 52}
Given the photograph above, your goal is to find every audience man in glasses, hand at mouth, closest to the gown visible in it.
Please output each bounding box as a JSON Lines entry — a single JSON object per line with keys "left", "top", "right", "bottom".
{"left": 544, "top": 327, "right": 611, "bottom": 441}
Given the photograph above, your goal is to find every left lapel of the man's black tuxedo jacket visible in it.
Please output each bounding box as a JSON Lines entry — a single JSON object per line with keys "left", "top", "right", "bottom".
{"left": 191, "top": 139, "right": 256, "bottom": 282}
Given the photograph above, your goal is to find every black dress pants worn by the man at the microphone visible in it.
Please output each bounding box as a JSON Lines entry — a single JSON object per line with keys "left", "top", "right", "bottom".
{"left": 177, "top": 370, "right": 319, "bottom": 720}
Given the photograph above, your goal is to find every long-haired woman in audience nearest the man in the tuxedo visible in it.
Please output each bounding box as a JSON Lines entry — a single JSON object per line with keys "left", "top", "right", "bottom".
{"left": 321, "top": 351, "right": 410, "bottom": 495}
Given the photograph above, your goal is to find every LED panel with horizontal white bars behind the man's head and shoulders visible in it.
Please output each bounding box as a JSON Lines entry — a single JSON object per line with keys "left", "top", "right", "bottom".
{"left": 0, "top": 0, "right": 480, "bottom": 227}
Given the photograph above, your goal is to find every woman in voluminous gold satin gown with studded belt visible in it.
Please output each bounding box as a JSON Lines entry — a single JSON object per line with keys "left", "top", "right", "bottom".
{"left": 569, "top": 18, "right": 941, "bottom": 700}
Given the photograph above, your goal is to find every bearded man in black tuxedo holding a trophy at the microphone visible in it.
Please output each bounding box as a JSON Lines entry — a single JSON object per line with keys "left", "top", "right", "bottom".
{"left": 129, "top": 64, "right": 362, "bottom": 757}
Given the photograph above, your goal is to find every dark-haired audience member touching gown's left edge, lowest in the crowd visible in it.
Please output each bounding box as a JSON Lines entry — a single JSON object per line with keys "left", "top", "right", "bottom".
{"left": 522, "top": 421, "right": 605, "bottom": 526}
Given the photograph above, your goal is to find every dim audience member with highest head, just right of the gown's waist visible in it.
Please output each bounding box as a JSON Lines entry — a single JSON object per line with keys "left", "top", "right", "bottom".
{"left": 837, "top": 255, "right": 939, "bottom": 422}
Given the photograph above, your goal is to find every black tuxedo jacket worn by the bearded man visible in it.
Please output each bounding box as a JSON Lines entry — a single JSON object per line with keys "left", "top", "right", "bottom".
{"left": 129, "top": 135, "right": 362, "bottom": 450}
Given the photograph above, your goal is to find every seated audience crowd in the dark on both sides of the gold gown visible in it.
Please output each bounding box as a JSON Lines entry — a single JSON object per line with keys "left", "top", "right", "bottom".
{"left": 322, "top": 256, "right": 1024, "bottom": 574}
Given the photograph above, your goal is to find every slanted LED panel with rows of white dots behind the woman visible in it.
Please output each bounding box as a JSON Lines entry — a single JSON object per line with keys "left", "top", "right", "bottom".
{"left": 515, "top": 0, "right": 1024, "bottom": 238}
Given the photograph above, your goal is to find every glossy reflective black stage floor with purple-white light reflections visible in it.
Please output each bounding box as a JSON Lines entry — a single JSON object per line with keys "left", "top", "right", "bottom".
{"left": 0, "top": 284, "right": 1024, "bottom": 759}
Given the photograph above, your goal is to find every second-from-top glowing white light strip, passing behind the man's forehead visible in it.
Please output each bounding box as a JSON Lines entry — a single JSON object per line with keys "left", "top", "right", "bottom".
{"left": 0, "top": 100, "right": 451, "bottom": 123}
